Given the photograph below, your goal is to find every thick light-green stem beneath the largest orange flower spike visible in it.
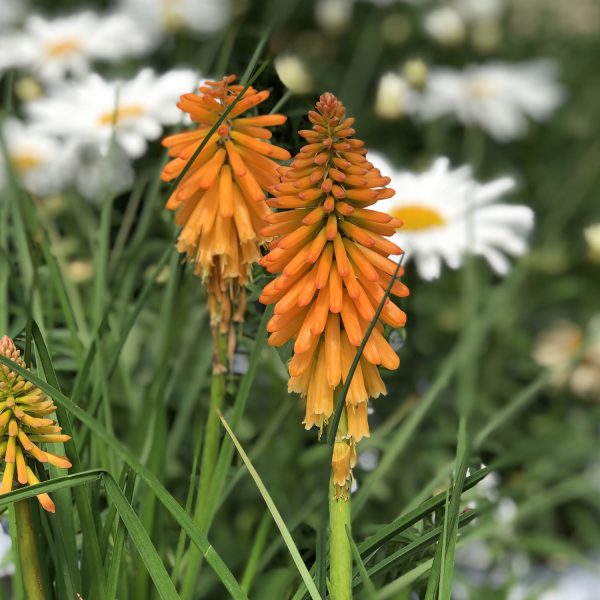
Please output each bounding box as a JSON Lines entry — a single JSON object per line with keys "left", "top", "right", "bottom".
{"left": 329, "top": 407, "right": 352, "bottom": 600}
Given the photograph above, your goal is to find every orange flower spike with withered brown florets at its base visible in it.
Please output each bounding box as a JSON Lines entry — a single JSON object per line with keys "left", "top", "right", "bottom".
{"left": 161, "top": 75, "right": 290, "bottom": 332}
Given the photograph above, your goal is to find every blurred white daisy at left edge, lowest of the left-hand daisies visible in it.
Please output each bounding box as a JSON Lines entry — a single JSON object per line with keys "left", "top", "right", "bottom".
{"left": 0, "top": 118, "right": 73, "bottom": 196}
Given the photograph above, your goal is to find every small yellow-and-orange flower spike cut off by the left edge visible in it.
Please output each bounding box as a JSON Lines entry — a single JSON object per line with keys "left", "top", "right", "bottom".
{"left": 0, "top": 336, "right": 71, "bottom": 513}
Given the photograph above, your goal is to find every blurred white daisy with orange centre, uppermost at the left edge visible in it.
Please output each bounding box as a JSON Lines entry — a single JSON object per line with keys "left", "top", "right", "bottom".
{"left": 0, "top": 11, "right": 153, "bottom": 82}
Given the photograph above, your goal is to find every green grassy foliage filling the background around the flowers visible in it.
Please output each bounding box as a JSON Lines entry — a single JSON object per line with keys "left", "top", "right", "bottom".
{"left": 0, "top": 1, "right": 600, "bottom": 600}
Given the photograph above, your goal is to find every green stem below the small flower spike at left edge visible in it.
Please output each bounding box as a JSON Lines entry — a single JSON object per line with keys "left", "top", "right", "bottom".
{"left": 14, "top": 499, "right": 46, "bottom": 600}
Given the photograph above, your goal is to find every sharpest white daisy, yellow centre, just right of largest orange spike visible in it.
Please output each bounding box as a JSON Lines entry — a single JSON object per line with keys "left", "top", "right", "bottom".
{"left": 369, "top": 153, "right": 534, "bottom": 280}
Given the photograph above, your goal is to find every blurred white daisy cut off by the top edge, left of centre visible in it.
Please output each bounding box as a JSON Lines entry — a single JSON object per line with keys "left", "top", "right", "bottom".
{"left": 121, "top": 0, "right": 231, "bottom": 33}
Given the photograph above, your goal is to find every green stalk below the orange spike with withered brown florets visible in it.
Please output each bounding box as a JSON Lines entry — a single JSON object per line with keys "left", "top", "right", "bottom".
{"left": 181, "top": 334, "right": 227, "bottom": 600}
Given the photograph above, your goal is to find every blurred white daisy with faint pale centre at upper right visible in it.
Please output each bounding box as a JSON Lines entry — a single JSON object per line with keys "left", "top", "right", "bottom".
{"left": 419, "top": 60, "right": 563, "bottom": 142}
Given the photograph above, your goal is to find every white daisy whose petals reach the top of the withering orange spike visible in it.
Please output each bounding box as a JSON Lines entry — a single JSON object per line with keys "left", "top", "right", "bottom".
{"left": 27, "top": 69, "right": 199, "bottom": 158}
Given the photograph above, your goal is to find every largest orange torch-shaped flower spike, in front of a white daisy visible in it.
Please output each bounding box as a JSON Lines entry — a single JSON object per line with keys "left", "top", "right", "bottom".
{"left": 260, "top": 93, "right": 408, "bottom": 495}
